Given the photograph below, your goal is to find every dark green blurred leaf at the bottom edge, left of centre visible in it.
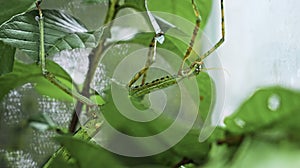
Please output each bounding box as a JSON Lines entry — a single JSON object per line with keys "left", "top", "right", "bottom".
{"left": 55, "top": 136, "right": 124, "bottom": 168}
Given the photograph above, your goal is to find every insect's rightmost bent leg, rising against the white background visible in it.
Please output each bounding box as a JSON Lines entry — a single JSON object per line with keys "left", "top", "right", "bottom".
{"left": 196, "top": 0, "right": 225, "bottom": 62}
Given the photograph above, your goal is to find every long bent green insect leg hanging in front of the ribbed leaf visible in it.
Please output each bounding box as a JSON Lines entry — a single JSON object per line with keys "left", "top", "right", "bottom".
{"left": 35, "top": 0, "right": 97, "bottom": 107}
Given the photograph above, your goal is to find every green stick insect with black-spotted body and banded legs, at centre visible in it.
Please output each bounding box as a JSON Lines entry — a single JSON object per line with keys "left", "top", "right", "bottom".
{"left": 128, "top": 0, "right": 225, "bottom": 97}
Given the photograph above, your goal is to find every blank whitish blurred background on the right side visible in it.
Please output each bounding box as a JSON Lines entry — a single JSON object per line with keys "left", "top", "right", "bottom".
{"left": 205, "top": 0, "right": 300, "bottom": 119}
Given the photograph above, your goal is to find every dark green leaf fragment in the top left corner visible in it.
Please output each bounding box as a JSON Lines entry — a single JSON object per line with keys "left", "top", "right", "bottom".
{"left": 0, "top": 0, "right": 35, "bottom": 25}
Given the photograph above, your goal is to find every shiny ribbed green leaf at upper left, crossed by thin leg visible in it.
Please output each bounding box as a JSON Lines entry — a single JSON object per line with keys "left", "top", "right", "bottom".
{"left": 0, "top": 10, "right": 102, "bottom": 60}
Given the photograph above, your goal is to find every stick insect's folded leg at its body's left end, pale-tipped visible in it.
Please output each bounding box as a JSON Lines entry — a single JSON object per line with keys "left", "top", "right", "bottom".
{"left": 128, "top": 32, "right": 164, "bottom": 87}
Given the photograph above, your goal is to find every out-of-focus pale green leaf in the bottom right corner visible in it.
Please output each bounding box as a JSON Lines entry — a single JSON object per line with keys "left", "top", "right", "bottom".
{"left": 203, "top": 138, "right": 300, "bottom": 168}
